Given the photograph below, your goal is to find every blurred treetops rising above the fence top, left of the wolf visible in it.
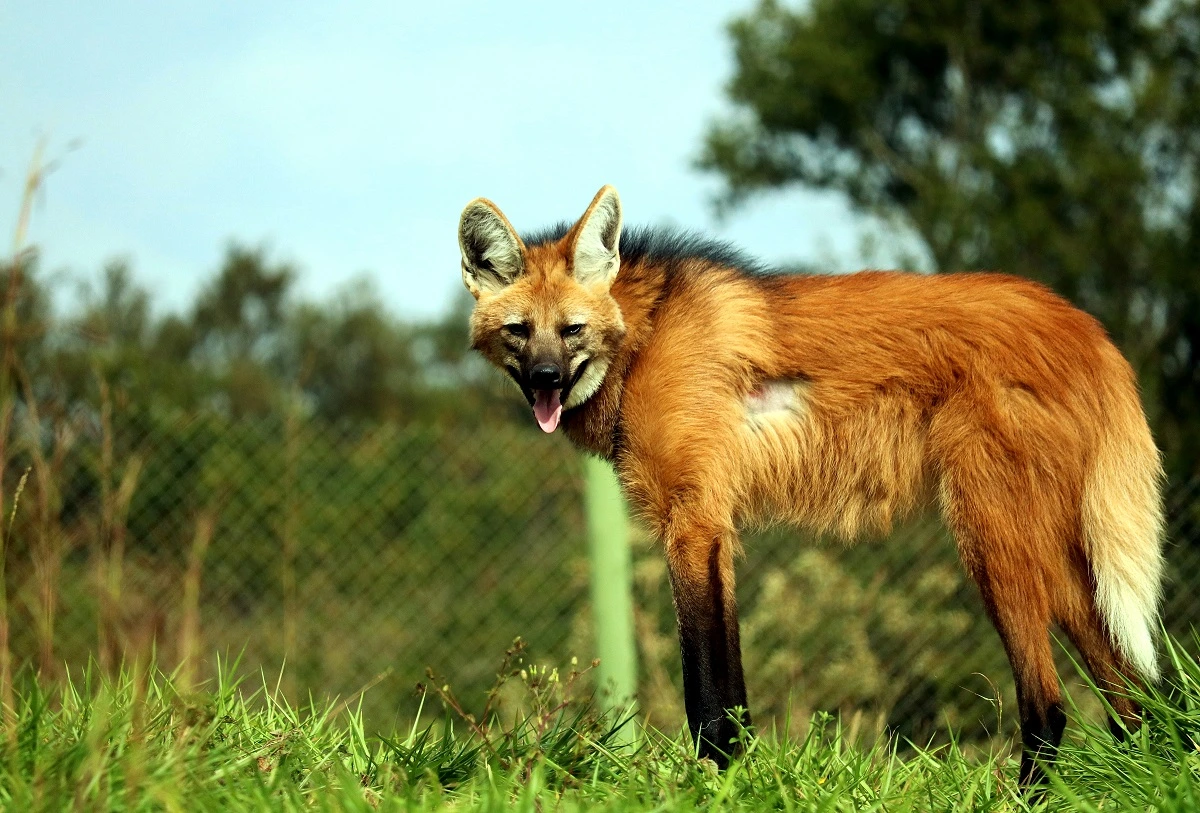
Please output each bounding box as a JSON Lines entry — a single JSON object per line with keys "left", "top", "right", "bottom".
{"left": 22, "top": 245, "right": 524, "bottom": 426}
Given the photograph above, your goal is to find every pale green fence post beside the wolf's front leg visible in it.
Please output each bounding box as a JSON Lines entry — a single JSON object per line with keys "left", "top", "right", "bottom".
{"left": 583, "top": 456, "right": 637, "bottom": 742}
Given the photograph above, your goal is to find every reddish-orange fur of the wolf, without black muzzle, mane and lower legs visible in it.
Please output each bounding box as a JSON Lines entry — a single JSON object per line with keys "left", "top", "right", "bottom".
{"left": 456, "top": 188, "right": 1159, "bottom": 777}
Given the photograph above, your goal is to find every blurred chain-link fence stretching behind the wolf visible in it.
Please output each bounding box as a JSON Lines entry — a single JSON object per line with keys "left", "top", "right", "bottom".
{"left": 4, "top": 410, "right": 1200, "bottom": 739}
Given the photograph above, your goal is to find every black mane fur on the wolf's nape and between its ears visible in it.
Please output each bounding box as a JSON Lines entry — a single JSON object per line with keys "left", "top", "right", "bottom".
{"left": 521, "top": 222, "right": 779, "bottom": 276}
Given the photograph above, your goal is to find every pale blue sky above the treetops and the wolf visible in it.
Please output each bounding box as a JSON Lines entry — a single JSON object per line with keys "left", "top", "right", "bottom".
{"left": 0, "top": 0, "right": 883, "bottom": 318}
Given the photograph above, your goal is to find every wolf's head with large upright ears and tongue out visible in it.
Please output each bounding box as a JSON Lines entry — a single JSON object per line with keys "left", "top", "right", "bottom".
{"left": 458, "top": 186, "right": 625, "bottom": 432}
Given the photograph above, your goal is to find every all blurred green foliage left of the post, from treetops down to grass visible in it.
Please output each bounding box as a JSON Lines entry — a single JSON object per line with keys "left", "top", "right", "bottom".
{"left": 0, "top": 245, "right": 586, "bottom": 712}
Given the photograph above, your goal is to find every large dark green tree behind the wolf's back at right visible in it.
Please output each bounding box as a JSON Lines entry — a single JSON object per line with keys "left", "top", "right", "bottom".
{"left": 700, "top": 0, "right": 1200, "bottom": 478}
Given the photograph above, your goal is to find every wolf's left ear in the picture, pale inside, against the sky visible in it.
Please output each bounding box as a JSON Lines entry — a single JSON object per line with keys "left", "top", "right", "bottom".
{"left": 458, "top": 198, "right": 524, "bottom": 300}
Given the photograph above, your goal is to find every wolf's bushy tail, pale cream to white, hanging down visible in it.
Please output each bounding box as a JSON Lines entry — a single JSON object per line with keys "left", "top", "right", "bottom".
{"left": 1082, "top": 392, "right": 1164, "bottom": 680}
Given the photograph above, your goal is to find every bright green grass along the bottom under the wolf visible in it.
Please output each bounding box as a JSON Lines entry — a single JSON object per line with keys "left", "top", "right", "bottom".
{"left": 0, "top": 645, "right": 1200, "bottom": 811}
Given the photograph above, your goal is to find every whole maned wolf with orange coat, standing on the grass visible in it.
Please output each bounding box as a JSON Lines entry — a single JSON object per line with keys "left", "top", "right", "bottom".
{"left": 458, "top": 187, "right": 1163, "bottom": 783}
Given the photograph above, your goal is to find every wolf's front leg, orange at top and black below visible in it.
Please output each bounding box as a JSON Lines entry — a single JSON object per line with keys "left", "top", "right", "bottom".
{"left": 665, "top": 528, "right": 750, "bottom": 767}
